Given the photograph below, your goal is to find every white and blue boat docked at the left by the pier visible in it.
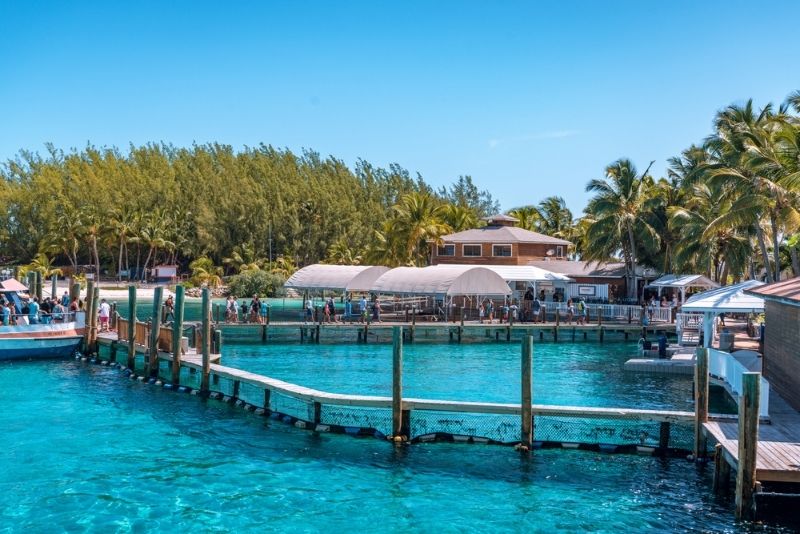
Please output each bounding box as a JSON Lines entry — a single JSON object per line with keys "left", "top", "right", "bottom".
{"left": 0, "top": 280, "right": 86, "bottom": 360}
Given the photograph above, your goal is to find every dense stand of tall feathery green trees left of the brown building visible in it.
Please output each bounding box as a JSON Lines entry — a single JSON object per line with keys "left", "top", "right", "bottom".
{"left": 0, "top": 144, "right": 496, "bottom": 279}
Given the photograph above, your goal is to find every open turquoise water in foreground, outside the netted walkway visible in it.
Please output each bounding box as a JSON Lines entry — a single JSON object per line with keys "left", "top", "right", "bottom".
{"left": 0, "top": 360, "right": 770, "bottom": 532}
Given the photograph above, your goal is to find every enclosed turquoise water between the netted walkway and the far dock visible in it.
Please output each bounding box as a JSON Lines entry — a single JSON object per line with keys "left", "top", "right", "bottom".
{"left": 222, "top": 342, "right": 694, "bottom": 410}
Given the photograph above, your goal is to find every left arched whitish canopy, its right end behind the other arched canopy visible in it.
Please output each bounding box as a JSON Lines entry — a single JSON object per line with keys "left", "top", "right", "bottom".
{"left": 283, "top": 263, "right": 389, "bottom": 291}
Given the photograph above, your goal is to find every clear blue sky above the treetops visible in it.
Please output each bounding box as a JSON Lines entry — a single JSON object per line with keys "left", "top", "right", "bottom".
{"left": 0, "top": 0, "right": 800, "bottom": 215}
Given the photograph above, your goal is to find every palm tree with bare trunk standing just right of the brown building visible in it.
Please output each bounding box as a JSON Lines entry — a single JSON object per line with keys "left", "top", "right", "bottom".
{"left": 585, "top": 159, "right": 659, "bottom": 298}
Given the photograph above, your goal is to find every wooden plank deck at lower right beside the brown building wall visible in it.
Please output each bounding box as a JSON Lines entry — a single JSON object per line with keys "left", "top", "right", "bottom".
{"left": 703, "top": 391, "right": 800, "bottom": 483}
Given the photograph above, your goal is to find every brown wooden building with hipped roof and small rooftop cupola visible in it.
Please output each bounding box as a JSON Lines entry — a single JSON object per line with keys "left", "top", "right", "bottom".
{"left": 431, "top": 215, "right": 572, "bottom": 265}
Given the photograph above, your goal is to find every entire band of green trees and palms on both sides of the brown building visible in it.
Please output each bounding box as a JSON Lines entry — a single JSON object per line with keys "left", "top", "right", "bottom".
{"left": 0, "top": 92, "right": 800, "bottom": 288}
